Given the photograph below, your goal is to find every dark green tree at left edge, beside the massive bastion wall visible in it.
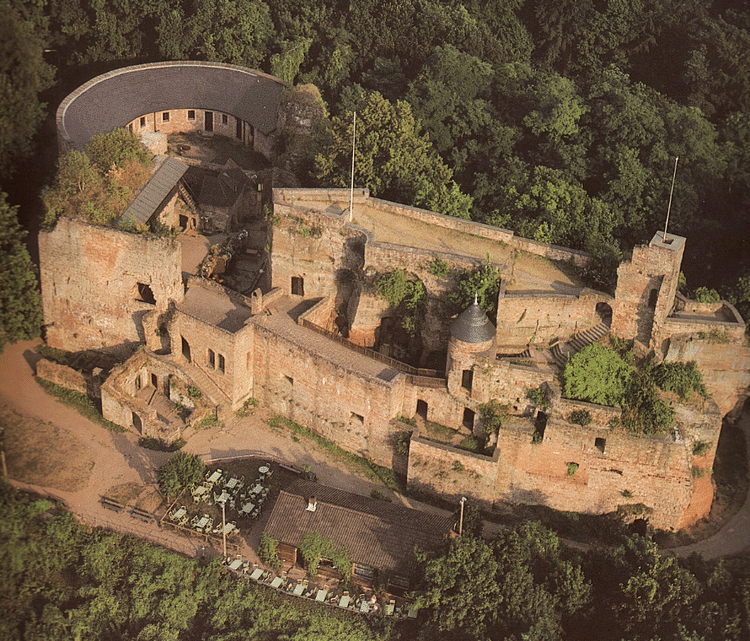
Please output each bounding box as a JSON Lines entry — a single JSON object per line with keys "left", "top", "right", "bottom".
{"left": 0, "top": 192, "right": 42, "bottom": 350}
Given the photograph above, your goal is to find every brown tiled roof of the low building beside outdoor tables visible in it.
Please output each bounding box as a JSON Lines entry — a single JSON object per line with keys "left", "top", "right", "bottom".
{"left": 266, "top": 480, "right": 453, "bottom": 576}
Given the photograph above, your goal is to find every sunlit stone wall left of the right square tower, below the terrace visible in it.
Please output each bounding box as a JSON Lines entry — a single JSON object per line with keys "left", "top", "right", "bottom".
{"left": 497, "top": 283, "right": 614, "bottom": 351}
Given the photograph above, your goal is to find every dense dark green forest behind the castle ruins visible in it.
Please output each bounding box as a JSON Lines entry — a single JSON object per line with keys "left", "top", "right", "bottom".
{"left": 0, "top": 0, "right": 750, "bottom": 311}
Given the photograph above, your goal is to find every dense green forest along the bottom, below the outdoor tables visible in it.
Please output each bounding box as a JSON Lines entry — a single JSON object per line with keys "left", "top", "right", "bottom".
{"left": 0, "top": 482, "right": 750, "bottom": 641}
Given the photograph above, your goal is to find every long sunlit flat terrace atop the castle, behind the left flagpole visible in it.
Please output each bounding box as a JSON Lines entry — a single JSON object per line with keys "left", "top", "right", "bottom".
{"left": 294, "top": 199, "right": 584, "bottom": 295}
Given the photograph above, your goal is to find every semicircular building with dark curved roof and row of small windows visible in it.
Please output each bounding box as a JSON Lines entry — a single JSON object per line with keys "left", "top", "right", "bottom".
{"left": 57, "top": 61, "right": 290, "bottom": 155}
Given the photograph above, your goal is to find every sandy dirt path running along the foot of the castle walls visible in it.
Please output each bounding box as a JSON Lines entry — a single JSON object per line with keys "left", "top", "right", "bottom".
{"left": 0, "top": 340, "right": 446, "bottom": 562}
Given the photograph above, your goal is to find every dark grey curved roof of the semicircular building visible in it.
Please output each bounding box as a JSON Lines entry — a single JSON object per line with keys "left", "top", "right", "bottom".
{"left": 57, "top": 61, "right": 289, "bottom": 149}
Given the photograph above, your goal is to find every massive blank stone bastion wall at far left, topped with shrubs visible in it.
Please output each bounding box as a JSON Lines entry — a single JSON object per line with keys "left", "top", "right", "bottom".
{"left": 39, "top": 218, "right": 183, "bottom": 351}
